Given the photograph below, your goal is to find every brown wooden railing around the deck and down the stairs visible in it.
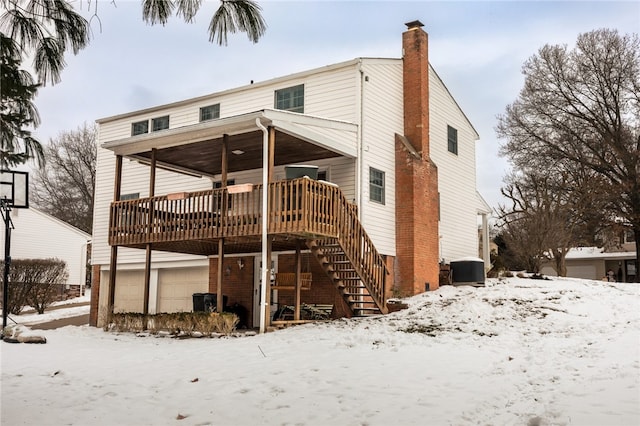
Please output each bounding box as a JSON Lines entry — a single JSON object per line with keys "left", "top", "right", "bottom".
{"left": 109, "top": 178, "right": 387, "bottom": 299}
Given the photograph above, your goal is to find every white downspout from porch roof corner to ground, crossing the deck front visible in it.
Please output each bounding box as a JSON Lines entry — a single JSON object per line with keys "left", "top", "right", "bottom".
{"left": 256, "top": 118, "right": 271, "bottom": 334}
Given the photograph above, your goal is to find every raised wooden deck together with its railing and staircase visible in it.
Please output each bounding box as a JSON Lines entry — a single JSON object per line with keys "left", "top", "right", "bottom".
{"left": 109, "top": 178, "right": 388, "bottom": 312}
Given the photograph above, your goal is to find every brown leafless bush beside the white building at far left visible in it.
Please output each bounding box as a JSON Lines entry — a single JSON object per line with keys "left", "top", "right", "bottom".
{"left": 0, "top": 259, "right": 69, "bottom": 315}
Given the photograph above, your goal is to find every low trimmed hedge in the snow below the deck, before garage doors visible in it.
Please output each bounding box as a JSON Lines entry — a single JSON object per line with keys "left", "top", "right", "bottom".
{"left": 105, "top": 312, "right": 239, "bottom": 335}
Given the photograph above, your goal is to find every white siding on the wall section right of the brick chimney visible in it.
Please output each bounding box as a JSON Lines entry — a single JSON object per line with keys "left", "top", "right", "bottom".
{"left": 429, "top": 69, "right": 478, "bottom": 261}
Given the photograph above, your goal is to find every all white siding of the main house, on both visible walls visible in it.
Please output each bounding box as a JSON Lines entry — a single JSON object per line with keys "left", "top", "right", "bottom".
{"left": 93, "top": 55, "right": 478, "bottom": 272}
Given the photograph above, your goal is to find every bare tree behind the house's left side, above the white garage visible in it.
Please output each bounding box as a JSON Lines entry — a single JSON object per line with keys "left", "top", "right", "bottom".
{"left": 30, "top": 123, "right": 97, "bottom": 233}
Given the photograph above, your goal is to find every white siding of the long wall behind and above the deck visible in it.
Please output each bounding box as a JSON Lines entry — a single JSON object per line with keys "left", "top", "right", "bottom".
{"left": 92, "top": 62, "right": 358, "bottom": 265}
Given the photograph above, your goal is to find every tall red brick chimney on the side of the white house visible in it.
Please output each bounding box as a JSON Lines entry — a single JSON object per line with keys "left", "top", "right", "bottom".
{"left": 394, "top": 21, "right": 440, "bottom": 295}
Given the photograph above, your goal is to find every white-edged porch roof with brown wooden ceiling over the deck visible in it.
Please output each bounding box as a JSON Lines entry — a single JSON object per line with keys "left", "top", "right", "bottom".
{"left": 103, "top": 110, "right": 357, "bottom": 177}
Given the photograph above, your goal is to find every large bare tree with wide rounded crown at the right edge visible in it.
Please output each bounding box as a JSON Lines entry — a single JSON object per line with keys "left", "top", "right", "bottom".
{"left": 496, "top": 29, "right": 640, "bottom": 280}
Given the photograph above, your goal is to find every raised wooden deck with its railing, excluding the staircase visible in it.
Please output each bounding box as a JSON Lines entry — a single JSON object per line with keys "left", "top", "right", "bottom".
{"left": 109, "top": 178, "right": 344, "bottom": 255}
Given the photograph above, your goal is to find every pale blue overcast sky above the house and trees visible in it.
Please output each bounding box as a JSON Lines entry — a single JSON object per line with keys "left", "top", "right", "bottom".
{"left": 35, "top": 0, "right": 640, "bottom": 211}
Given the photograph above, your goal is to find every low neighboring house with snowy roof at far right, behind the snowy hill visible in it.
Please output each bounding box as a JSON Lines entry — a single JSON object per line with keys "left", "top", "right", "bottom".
{"left": 541, "top": 231, "right": 638, "bottom": 283}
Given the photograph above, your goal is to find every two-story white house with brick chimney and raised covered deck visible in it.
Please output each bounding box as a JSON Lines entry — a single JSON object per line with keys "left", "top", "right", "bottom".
{"left": 91, "top": 21, "right": 490, "bottom": 330}
